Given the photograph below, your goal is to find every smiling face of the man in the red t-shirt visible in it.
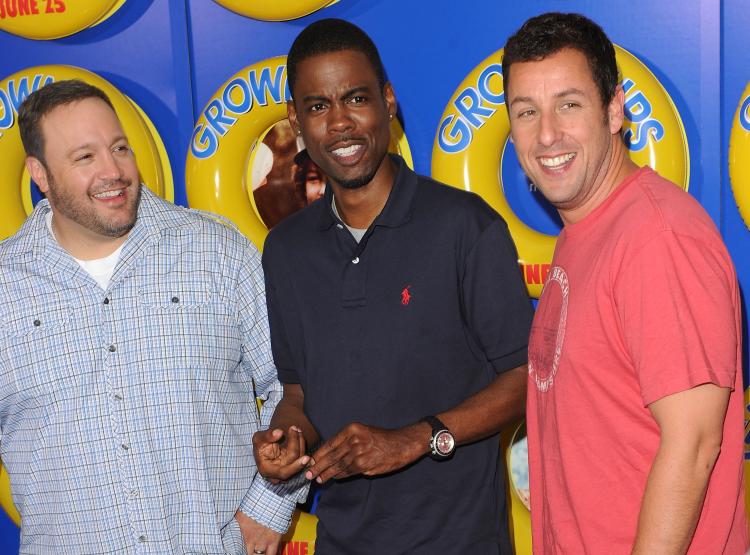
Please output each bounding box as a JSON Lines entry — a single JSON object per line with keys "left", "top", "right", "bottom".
{"left": 506, "top": 48, "right": 632, "bottom": 223}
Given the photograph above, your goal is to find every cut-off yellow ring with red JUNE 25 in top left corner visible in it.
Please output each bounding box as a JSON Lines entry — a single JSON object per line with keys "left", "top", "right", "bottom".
{"left": 0, "top": 0, "right": 125, "bottom": 40}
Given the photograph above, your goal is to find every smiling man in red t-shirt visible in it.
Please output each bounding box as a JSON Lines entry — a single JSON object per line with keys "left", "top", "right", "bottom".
{"left": 503, "top": 13, "right": 748, "bottom": 554}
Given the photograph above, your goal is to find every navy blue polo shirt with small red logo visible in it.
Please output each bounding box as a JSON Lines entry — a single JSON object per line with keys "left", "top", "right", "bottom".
{"left": 263, "top": 157, "right": 532, "bottom": 555}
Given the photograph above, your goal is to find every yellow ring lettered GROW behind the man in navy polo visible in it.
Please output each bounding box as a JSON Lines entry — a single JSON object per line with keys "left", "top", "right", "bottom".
{"left": 185, "top": 56, "right": 413, "bottom": 248}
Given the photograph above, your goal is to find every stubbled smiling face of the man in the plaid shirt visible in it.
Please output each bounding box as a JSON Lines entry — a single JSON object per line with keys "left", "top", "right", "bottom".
{"left": 28, "top": 98, "right": 140, "bottom": 250}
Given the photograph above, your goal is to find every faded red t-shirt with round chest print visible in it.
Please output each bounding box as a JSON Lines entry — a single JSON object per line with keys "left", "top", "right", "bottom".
{"left": 527, "top": 168, "right": 748, "bottom": 554}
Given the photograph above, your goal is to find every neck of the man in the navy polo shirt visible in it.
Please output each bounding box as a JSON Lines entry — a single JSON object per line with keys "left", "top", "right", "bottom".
{"left": 332, "top": 156, "right": 396, "bottom": 229}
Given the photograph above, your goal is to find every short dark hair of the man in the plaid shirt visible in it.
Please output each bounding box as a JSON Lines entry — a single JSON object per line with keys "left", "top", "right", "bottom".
{"left": 18, "top": 79, "right": 115, "bottom": 166}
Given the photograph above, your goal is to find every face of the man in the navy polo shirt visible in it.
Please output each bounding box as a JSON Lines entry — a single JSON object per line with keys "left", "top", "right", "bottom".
{"left": 288, "top": 50, "right": 396, "bottom": 193}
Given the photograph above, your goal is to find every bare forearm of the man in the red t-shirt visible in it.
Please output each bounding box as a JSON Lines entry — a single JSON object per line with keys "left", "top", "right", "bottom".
{"left": 633, "top": 434, "right": 719, "bottom": 555}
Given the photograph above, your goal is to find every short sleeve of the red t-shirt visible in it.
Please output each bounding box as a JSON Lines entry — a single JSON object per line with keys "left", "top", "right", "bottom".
{"left": 615, "top": 230, "right": 738, "bottom": 406}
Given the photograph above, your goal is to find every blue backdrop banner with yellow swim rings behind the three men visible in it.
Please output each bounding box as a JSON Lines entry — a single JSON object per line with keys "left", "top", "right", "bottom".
{"left": 0, "top": 0, "right": 750, "bottom": 555}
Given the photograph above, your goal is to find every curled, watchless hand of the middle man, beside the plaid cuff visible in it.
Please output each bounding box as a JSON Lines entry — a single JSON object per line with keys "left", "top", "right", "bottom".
{"left": 253, "top": 426, "right": 310, "bottom": 484}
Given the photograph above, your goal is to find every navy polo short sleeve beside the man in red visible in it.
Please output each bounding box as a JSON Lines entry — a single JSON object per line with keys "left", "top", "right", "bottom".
{"left": 462, "top": 219, "right": 533, "bottom": 373}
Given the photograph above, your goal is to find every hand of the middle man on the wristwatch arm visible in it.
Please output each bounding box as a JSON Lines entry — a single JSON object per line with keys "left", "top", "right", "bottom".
{"left": 305, "top": 422, "right": 430, "bottom": 484}
